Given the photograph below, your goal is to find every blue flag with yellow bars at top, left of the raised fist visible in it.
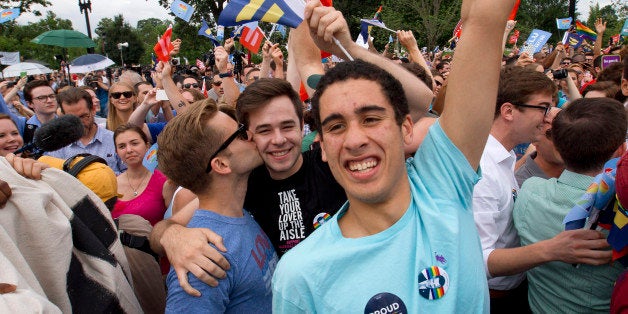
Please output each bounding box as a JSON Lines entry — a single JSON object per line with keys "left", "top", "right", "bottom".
{"left": 218, "top": 0, "right": 305, "bottom": 28}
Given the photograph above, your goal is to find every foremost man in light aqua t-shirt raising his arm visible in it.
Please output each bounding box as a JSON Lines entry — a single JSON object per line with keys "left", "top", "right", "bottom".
{"left": 273, "top": 0, "right": 514, "bottom": 313}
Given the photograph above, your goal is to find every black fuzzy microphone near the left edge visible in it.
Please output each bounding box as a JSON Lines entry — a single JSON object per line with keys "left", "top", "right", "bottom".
{"left": 15, "top": 114, "right": 84, "bottom": 154}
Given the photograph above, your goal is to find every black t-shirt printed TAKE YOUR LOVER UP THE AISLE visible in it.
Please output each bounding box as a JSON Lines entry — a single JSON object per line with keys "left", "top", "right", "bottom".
{"left": 244, "top": 148, "right": 347, "bottom": 256}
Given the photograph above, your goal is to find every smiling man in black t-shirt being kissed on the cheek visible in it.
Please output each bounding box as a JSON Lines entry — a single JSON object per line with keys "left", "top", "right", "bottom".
{"left": 236, "top": 79, "right": 347, "bottom": 256}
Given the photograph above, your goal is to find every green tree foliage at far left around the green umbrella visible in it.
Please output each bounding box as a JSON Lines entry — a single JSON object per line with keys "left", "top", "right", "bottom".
{"left": 0, "top": 12, "right": 87, "bottom": 68}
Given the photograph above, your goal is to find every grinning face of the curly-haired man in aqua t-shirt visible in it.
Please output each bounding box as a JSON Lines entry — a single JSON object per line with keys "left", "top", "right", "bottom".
{"left": 320, "top": 79, "right": 412, "bottom": 206}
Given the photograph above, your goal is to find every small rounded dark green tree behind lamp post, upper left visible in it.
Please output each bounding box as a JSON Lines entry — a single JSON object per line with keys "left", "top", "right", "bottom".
{"left": 95, "top": 14, "right": 146, "bottom": 65}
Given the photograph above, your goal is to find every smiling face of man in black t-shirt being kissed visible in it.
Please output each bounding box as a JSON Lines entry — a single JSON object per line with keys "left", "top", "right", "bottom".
{"left": 249, "top": 96, "right": 303, "bottom": 180}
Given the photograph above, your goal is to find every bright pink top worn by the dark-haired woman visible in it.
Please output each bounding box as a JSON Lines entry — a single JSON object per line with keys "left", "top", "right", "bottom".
{"left": 111, "top": 170, "right": 168, "bottom": 226}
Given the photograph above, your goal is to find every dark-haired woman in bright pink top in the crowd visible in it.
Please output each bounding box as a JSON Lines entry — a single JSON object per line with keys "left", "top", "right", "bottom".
{"left": 111, "top": 124, "right": 175, "bottom": 225}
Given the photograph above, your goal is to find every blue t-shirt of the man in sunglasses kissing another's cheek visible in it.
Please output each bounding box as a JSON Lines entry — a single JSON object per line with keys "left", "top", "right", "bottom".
{"left": 166, "top": 210, "right": 277, "bottom": 313}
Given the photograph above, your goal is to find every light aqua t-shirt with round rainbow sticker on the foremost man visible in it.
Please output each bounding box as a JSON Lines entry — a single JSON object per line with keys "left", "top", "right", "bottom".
{"left": 273, "top": 122, "right": 489, "bottom": 314}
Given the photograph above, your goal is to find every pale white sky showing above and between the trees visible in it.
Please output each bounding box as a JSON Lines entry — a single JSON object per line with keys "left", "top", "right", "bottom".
{"left": 17, "top": 0, "right": 611, "bottom": 34}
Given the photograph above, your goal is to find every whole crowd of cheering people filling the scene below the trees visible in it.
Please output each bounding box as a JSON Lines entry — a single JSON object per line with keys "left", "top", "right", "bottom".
{"left": 0, "top": 0, "right": 628, "bottom": 313}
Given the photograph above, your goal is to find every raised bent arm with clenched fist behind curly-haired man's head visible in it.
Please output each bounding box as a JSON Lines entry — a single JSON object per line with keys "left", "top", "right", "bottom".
{"left": 305, "top": 1, "right": 434, "bottom": 121}
